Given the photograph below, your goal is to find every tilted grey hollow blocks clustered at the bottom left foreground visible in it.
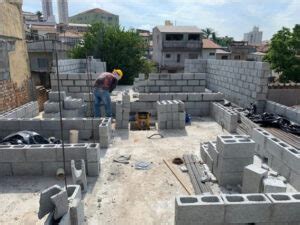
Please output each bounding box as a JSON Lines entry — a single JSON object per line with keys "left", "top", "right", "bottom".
{"left": 38, "top": 185, "right": 84, "bottom": 225}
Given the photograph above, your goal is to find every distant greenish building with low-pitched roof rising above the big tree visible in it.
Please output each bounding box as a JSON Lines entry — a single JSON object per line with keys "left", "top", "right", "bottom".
{"left": 69, "top": 8, "right": 119, "bottom": 25}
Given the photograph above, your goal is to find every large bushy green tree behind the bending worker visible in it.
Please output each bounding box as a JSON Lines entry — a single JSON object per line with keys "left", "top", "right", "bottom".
{"left": 71, "top": 23, "right": 146, "bottom": 84}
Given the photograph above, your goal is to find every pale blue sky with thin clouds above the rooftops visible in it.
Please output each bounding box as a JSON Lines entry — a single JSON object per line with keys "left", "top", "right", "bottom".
{"left": 23, "top": 0, "right": 300, "bottom": 40}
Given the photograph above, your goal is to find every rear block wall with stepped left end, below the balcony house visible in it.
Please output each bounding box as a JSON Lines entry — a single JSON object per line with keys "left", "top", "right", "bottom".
{"left": 134, "top": 73, "right": 206, "bottom": 93}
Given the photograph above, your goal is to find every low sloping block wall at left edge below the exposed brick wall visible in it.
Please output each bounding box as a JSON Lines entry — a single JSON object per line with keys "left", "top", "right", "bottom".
{"left": 0, "top": 101, "right": 39, "bottom": 118}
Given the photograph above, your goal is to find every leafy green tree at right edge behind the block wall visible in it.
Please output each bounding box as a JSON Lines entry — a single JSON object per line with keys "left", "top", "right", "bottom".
{"left": 264, "top": 24, "right": 300, "bottom": 82}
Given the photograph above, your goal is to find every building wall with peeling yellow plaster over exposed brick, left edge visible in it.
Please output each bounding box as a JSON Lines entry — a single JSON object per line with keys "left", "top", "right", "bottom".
{"left": 0, "top": 0, "right": 32, "bottom": 112}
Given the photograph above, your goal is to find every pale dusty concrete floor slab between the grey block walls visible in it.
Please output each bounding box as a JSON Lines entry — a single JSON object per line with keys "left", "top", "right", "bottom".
{"left": 0, "top": 118, "right": 223, "bottom": 225}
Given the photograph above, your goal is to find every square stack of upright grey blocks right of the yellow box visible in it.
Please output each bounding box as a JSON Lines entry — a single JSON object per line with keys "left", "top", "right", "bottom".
{"left": 157, "top": 100, "right": 185, "bottom": 130}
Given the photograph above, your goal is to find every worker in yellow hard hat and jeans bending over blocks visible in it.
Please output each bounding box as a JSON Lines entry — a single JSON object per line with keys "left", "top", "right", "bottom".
{"left": 94, "top": 69, "right": 123, "bottom": 117}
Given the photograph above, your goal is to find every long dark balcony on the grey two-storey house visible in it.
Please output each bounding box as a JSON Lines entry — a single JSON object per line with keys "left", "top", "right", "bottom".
{"left": 163, "top": 41, "right": 202, "bottom": 51}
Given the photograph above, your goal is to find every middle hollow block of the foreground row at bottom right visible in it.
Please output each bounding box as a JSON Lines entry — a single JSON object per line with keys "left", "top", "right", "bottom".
{"left": 221, "top": 194, "right": 271, "bottom": 223}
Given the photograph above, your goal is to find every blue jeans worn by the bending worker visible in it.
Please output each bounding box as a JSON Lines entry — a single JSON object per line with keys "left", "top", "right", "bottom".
{"left": 94, "top": 88, "right": 112, "bottom": 117}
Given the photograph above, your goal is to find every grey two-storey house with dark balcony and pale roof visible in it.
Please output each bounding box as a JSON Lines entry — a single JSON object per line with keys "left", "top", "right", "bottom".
{"left": 152, "top": 25, "right": 202, "bottom": 72}
